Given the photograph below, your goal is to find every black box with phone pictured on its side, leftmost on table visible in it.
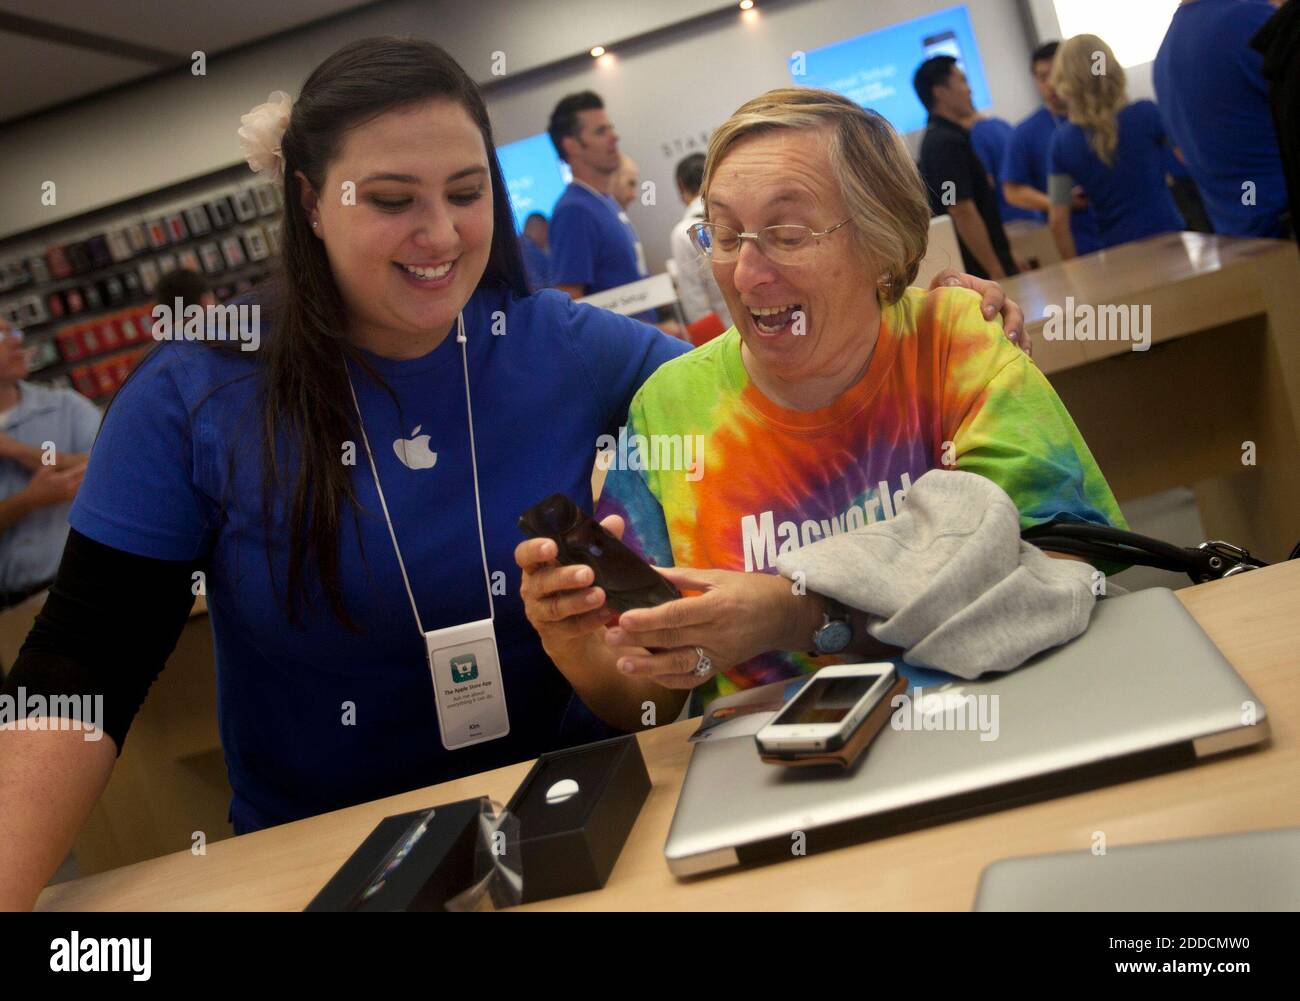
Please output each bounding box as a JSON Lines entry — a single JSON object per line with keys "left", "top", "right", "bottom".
{"left": 306, "top": 798, "right": 488, "bottom": 911}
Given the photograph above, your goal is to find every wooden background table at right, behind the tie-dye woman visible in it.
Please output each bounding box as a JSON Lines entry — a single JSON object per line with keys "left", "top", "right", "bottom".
{"left": 1005, "top": 233, "right": 1300, "bottom": 562}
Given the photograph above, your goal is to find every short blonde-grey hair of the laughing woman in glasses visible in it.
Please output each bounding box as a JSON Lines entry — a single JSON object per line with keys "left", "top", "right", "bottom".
{"left": 699, "top": 87, "right": 930, "bottom": 306}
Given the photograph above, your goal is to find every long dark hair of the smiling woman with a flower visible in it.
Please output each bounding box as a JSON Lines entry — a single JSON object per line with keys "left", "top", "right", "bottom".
{"left": 257, "top": 38, "right": 528, "bottom": 628}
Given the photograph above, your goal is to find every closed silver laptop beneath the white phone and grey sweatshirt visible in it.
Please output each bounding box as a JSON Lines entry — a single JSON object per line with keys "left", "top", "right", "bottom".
{"left": 664, "top": 588, "right": 1269, "bottom": 876}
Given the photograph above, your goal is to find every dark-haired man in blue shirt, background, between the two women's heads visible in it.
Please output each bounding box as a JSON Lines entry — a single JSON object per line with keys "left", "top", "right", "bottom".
{"left": 546, "top": 91, "right": 657, "bottom": 324}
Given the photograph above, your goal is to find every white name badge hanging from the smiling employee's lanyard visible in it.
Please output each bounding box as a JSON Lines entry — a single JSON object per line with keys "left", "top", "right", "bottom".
{"left": 424, "top": 619, "right": 510, "bottom": 750}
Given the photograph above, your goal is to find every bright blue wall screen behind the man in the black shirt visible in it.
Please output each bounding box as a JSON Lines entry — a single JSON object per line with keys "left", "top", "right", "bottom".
{"left": 789, "top": 7, "right": 992, "bottom": 133}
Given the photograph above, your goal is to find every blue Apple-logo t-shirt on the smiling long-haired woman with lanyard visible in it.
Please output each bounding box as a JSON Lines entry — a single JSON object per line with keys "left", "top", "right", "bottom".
{"left": 72, "top": 289, "right": 688, "bottom": 832}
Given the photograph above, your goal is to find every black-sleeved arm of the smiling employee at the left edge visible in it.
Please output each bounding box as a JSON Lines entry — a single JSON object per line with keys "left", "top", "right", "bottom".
{"left": 0, "top": 530, "right": 194, "bottom": 909}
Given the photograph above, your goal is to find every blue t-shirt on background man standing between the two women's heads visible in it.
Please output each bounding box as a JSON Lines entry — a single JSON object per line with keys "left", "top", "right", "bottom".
{"left": 549, "top": 181, "right": 654, "bottom": 324}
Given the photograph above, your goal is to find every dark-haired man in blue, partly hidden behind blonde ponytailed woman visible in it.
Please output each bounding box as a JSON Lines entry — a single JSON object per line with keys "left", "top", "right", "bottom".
{"left": 997, "top": 42, "right": 1101, "bottom": 254}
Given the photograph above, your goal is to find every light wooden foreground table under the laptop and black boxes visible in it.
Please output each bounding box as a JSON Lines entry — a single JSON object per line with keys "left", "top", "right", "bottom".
{"left": 38, "top": 560, "right": 1300, "bottom": 910}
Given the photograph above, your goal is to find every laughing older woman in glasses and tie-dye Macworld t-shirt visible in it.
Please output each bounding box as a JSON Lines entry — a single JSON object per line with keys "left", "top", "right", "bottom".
{"left": 517, "top": 88, "right": 1123, "bottom": 701}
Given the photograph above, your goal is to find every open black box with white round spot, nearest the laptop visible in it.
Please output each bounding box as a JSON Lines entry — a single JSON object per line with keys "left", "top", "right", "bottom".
{"left": 501, "top": 736, "right": 650, "bottom": 904}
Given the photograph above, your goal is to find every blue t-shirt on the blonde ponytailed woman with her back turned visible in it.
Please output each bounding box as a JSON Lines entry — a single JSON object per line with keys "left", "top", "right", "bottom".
{"left": 1048, "top": 101, "right": 1184, "bottom": 247}
